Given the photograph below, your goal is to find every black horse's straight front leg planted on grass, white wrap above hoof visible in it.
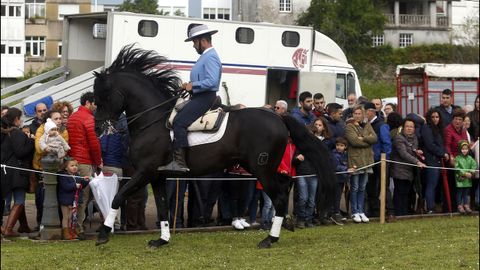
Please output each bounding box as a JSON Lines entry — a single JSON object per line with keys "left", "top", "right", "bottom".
{"left": 148, "top": 176, "right": 170, "bottom": 248}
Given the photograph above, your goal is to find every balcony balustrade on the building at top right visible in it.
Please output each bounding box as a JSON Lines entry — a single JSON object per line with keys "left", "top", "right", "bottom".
{"left": 385, "top": 14, "right": 448, "bottom": 28}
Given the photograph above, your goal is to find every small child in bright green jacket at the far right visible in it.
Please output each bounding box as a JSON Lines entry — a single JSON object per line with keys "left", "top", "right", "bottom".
{"left": 455, "top": 140, "right": 477, "bottom": 215}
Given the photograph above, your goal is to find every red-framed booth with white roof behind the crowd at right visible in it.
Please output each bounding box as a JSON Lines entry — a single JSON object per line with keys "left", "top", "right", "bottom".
{"left": 396, "top": 63, "right": 480, "bottom": 116}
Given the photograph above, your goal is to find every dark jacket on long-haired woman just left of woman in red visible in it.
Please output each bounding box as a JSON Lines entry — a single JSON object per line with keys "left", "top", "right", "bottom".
{"left": 420, "top": 124, "right": 446, "bottom": 167}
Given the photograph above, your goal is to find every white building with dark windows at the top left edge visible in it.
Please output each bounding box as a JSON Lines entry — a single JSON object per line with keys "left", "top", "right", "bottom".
{"left": 1, "top": 0, "right": 25, "bottom": 88}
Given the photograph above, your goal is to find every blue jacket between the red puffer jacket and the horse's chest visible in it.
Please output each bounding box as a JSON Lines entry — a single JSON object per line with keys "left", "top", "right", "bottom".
{"left": 100, "top": 114, "right": 128, "bottom": 168}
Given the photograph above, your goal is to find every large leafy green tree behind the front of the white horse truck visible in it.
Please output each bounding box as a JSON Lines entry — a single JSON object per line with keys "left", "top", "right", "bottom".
{"left": 297, "top": 0, "right": 385, "bottom": 54}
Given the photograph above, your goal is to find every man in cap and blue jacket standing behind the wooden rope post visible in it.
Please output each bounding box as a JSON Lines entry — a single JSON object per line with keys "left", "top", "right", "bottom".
{"left": 364, "top": 102, "right": 392, "bottom": 217}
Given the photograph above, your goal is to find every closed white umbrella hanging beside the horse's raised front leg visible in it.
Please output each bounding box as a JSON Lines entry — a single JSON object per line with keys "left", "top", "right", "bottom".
{"left": 90, "top": 172, "right": 118, "bottom": 231}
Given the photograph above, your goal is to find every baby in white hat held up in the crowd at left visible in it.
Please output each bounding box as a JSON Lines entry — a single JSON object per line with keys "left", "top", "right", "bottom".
{"left": 40, "top": 118, "right": 70, "bottom": 159}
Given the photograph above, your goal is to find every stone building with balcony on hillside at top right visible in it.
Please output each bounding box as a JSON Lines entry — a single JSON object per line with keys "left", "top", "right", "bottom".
{"left": 372, "top": 0, "right": 458, "bottom": 48}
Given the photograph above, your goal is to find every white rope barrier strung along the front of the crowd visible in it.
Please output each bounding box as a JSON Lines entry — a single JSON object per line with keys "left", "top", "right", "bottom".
{"left": 1, "top": 159, "right": 479, "bottom": 181}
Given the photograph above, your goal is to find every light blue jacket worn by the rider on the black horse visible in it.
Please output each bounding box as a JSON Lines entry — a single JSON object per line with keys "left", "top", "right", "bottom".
{"left": 190, "top": 48, "right": 222, "bottom": 94}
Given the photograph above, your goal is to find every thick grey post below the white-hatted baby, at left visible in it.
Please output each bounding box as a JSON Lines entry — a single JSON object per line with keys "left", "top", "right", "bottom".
{"left": 40, "top": 155, "right": 62, "bottom": 240}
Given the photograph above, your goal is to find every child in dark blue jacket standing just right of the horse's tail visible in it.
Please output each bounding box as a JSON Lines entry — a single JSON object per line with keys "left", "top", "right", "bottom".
{"left": 331, "top": 137, "right": 355, "bottom": 225}
